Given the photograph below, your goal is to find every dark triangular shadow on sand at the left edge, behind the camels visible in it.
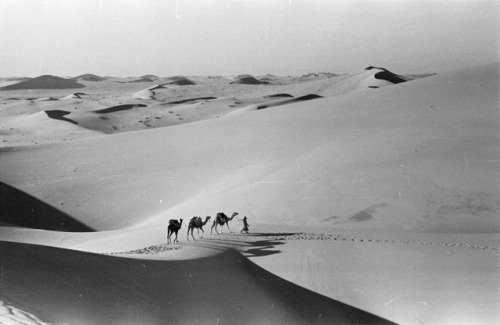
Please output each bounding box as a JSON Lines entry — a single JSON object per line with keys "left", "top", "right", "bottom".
{"left": 0, "top": 182, "right": 94, "bottom": 232}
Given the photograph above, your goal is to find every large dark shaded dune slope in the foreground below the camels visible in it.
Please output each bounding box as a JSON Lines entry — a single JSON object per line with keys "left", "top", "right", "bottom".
{"left": 0, "top": 242, "right": 392, "bottom": 324}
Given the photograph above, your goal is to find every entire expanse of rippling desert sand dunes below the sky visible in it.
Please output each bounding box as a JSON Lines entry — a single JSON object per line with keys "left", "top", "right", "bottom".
{"left": 0, "top": 63, "right": 500, "bottom": 324}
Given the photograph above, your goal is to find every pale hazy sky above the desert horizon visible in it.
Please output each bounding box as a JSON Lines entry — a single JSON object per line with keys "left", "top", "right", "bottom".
{"left": 0, "top": 0, "right": 500, "bottom": 77}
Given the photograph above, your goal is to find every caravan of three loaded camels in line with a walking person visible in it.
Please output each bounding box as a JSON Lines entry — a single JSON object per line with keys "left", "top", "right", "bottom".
{"left": 167, "top": 212, "right": 249, "bottom": 244}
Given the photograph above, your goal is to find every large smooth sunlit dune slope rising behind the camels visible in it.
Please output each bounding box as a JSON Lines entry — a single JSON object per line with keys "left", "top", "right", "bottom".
{"left": 0, "top": 64, "right": 499, "bottom": 233}
